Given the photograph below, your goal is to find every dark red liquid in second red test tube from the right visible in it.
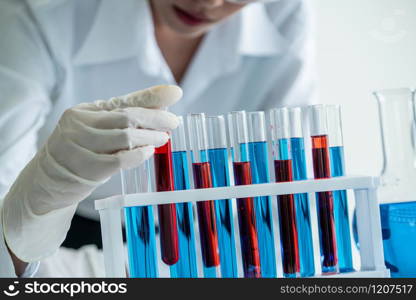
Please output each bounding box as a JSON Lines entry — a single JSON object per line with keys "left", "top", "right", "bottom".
{"left": 274, "top": 160, "right": 300, "bottom": 274}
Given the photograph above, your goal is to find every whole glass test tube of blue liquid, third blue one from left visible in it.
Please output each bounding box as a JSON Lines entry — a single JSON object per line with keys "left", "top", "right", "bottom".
{"left": 206, "top": 116, "right": 238, "bottom": 278}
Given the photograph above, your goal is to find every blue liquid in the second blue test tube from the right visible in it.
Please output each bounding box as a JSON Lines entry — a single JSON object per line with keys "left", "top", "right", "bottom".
{"left": 290, "top": 138, "right": 315, "bottom": 277}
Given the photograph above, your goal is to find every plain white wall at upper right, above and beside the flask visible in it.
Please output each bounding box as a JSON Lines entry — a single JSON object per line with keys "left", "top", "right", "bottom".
{"left": 308, "top": 0, "right": 416, "bottom": 175}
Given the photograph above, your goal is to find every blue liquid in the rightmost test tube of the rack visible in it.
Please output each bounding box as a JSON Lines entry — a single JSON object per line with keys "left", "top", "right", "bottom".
{"left": 329, "top": 147, "right": 354, "bottom": 273}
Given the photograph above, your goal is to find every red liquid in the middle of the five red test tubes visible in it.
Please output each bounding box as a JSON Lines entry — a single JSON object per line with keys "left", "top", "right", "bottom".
{"left": 234, "top": 162, "right": 261, "bottom": 278}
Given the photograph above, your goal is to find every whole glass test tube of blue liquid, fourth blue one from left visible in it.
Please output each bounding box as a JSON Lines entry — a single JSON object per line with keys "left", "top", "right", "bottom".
{"left": 248, "top": 111, "right": 277, "bottom": 278}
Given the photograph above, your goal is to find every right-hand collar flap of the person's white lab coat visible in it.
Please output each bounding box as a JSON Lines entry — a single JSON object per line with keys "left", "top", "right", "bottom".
{"left": 182, "top": 3, "right": 287, "bottom": 101}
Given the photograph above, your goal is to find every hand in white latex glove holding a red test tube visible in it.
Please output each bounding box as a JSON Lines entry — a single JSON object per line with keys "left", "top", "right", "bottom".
{"left": 0, "top": 86, "right": 182, "bottom": 262}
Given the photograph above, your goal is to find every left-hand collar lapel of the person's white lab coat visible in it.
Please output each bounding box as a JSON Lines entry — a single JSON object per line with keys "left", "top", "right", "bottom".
{"left": 73, "top": 0, "right": 164, "bottom": 76}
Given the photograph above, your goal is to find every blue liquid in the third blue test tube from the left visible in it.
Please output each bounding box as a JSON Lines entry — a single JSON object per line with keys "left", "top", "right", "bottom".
{"left": 208, "top": 148, "right": 238, "bottom": 278}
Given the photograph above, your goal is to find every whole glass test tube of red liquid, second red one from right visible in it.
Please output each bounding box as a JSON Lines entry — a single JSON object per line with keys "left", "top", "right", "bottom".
{"left": 270, "top": 108, "right": 300, "bottom": 277}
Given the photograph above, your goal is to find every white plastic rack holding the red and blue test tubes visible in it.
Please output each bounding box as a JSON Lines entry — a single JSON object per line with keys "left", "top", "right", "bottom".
{"left": 95, "top": 176, "right": 390, "bottom": 278}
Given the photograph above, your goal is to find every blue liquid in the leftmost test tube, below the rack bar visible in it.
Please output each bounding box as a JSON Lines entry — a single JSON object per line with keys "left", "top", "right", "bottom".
{"left": 124, "top": 206, "right": 158, "bottom": 278}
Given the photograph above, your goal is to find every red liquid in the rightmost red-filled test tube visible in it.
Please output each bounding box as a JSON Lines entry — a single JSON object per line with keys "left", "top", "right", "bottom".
{"left": 312, "top": 135, "right": 338, "bottom": 267}
